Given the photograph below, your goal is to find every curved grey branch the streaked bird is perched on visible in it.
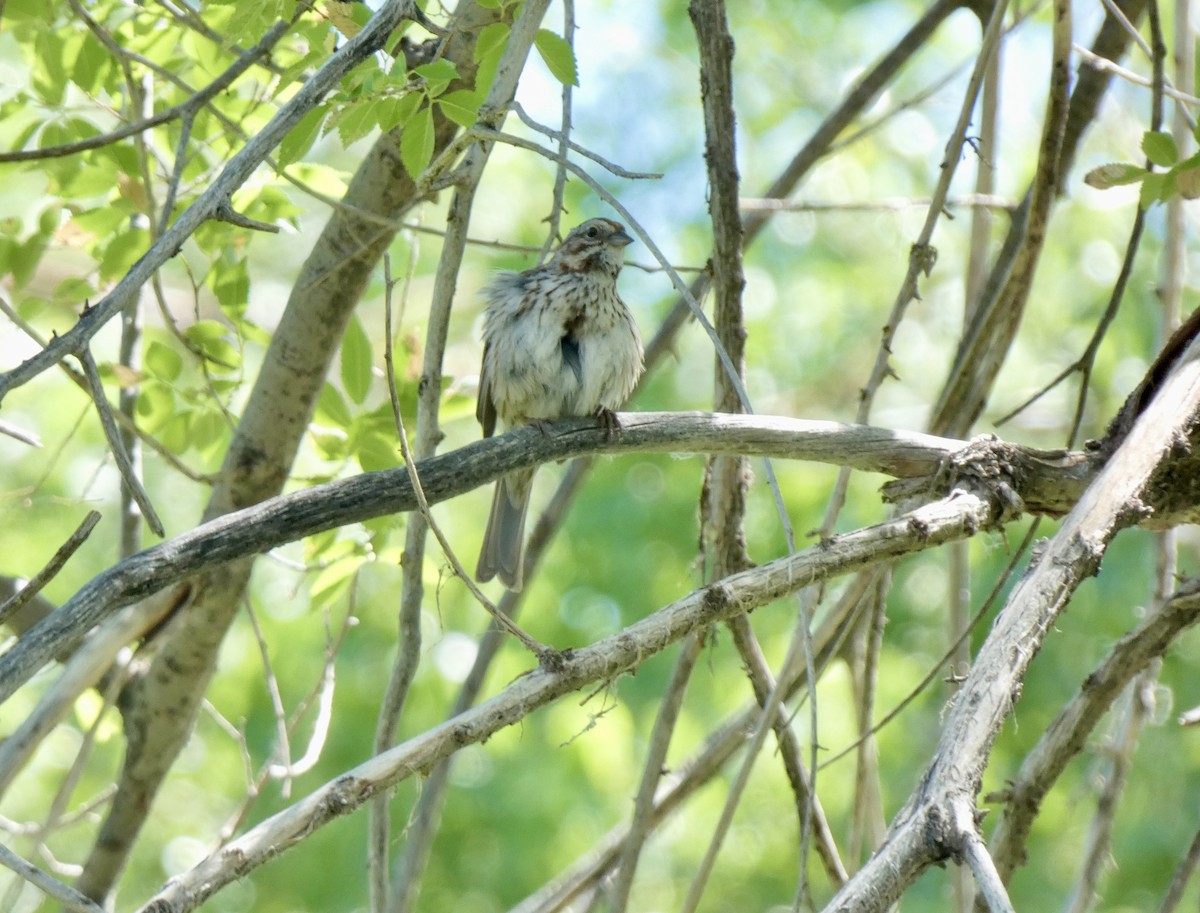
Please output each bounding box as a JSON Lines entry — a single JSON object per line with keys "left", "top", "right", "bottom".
{"left": 0, "top": 413, "right": 1132, "bottom": 701}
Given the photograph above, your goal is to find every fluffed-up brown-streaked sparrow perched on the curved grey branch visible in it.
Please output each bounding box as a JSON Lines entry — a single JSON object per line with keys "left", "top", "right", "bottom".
{"left": 475, "top": 218, "right": 642, "bottom": 590}
